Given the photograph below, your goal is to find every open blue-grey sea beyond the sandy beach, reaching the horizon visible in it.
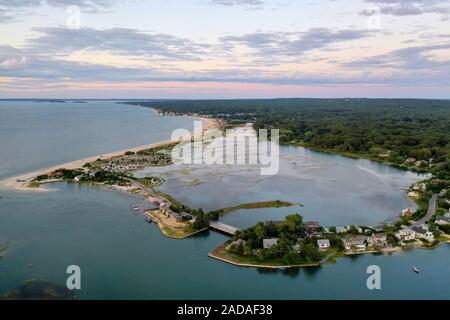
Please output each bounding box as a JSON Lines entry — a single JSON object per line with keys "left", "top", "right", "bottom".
{"left": 0, "top": 101, "right": 193, "bottom": 180}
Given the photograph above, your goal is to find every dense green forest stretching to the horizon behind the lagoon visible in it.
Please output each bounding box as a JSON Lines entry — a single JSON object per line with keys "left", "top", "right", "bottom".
{"left": 128, "top": 99, "right": 450, "bottom": 180}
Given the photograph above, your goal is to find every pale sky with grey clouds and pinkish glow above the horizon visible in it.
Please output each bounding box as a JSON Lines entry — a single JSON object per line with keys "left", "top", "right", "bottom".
{"left": 0, "top": 0, "right": 450, "bottom": 99}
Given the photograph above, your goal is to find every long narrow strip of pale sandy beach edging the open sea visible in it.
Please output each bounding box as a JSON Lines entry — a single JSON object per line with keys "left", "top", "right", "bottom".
{"left": 0, "top": 118, "right": 219, "bottom": 192}
